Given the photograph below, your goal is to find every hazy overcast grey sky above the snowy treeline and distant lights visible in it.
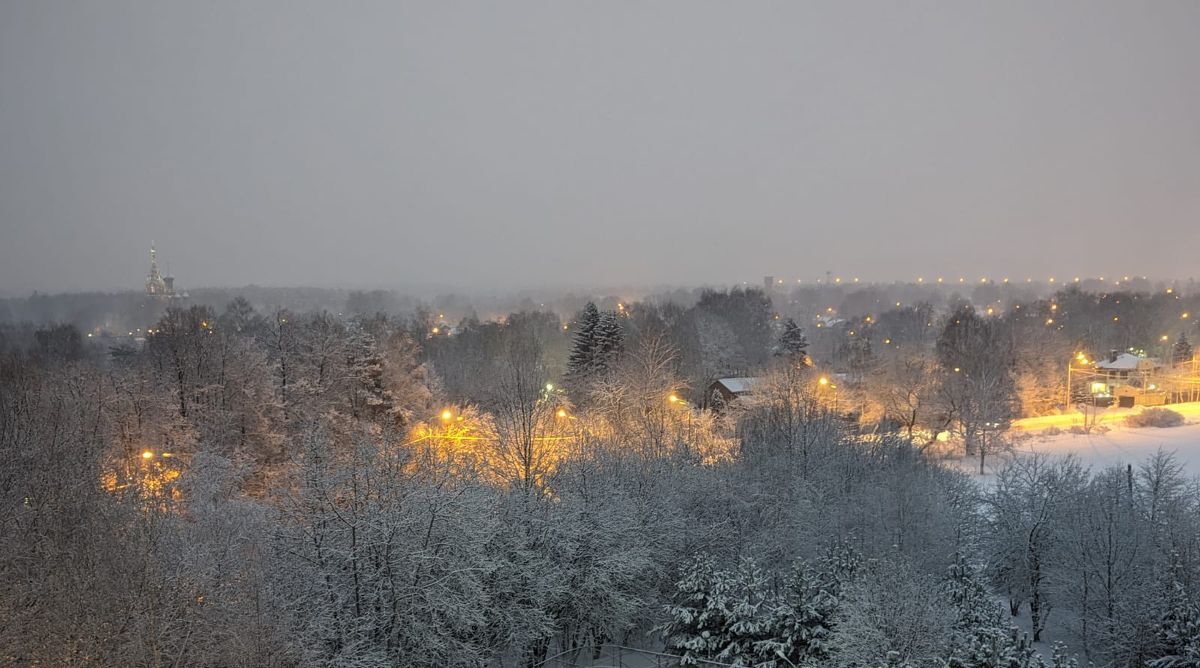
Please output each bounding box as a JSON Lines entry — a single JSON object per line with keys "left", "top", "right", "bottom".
{"left": 0, "top": 0, "right": 1200, "bottom": 294}
